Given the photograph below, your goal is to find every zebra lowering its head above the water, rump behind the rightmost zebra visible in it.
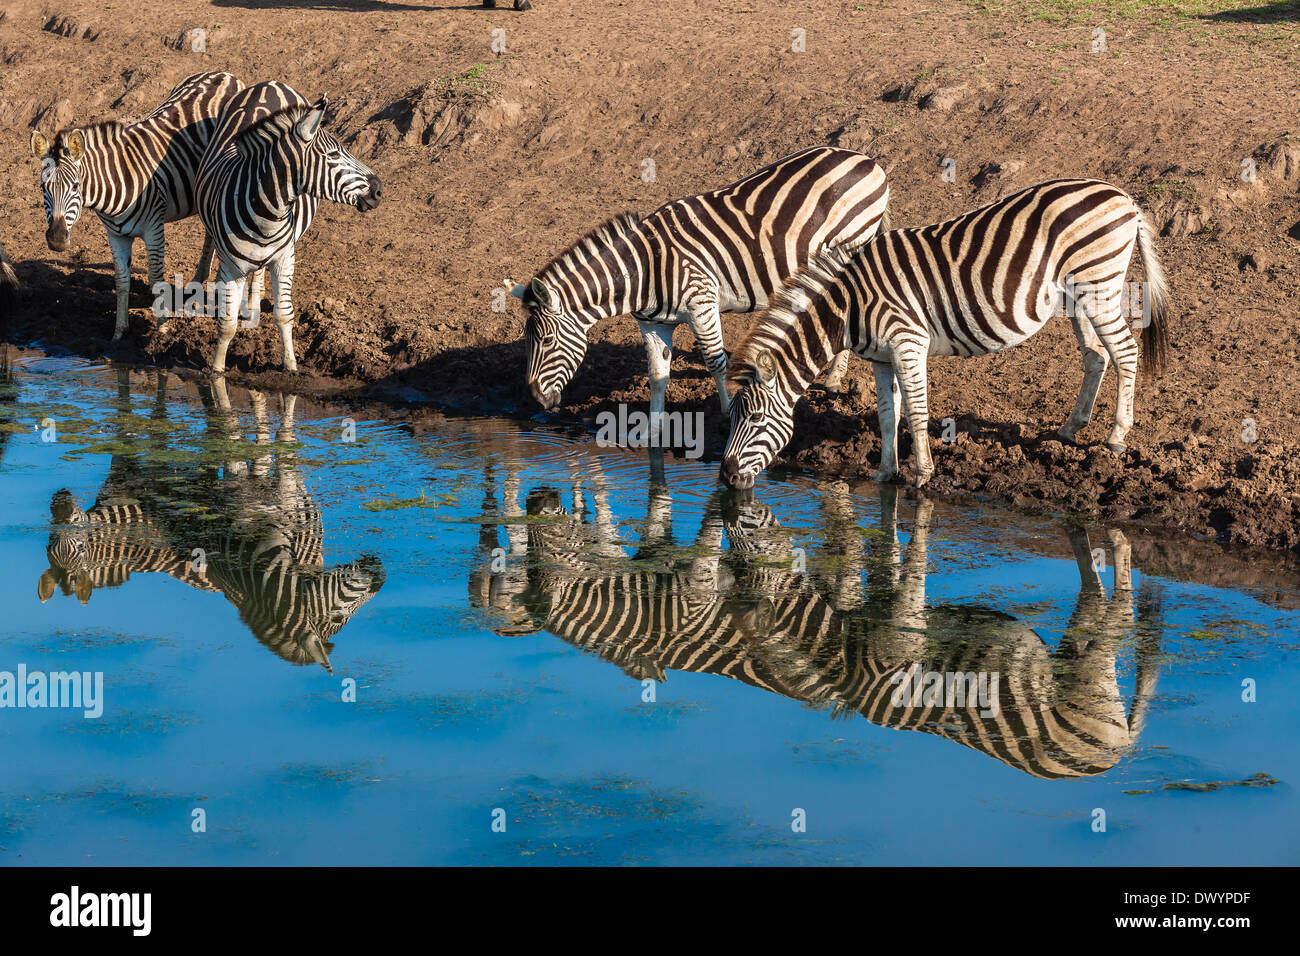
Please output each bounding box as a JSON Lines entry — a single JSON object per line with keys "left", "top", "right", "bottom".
{"left": 512, "top": 146, "right": 889, "bottom": 415}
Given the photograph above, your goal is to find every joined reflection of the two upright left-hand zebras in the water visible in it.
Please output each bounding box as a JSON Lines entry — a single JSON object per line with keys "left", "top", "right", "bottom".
{"left": 38, "top": 371, "right": 384, "bottom": 674}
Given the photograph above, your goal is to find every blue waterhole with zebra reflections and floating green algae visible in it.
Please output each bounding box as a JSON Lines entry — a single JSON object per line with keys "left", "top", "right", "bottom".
{"left": 0, "top": 352, "right": 1300, "bottom": 865}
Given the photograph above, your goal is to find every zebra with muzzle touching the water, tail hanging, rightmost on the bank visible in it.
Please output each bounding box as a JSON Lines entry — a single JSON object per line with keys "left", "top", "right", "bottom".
{"left": 719, "top": 179, "right": 1167, "bottom": 488}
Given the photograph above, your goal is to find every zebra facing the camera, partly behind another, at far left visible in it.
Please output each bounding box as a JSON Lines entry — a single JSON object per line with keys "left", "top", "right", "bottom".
{"left": 31, "top": 73, "right": 243, "bottom": 342}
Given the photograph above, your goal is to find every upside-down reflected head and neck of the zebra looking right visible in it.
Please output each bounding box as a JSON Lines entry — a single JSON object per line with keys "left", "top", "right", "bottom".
{"left": 238, "top": 554, "right": 385, "bottom": 674}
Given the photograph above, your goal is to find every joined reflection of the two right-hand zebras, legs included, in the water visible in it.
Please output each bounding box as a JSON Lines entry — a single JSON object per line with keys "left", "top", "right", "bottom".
{"left": 469, "top": 475, "right": 1160, "bottom": 779}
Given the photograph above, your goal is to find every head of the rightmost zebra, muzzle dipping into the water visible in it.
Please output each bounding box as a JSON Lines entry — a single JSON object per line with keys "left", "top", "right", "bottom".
{"left": 718, "top": 350, "right": 794, "bottom": 488}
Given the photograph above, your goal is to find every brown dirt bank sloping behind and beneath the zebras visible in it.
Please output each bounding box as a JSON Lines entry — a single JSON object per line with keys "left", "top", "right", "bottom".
{"left": 0, "top": 0, "right": 1300, "bottom": 559}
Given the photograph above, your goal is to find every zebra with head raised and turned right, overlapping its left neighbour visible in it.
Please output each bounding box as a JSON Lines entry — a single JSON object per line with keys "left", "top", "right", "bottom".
{"left": 198, "top": 82, "right": 384, "bottom": 373}
